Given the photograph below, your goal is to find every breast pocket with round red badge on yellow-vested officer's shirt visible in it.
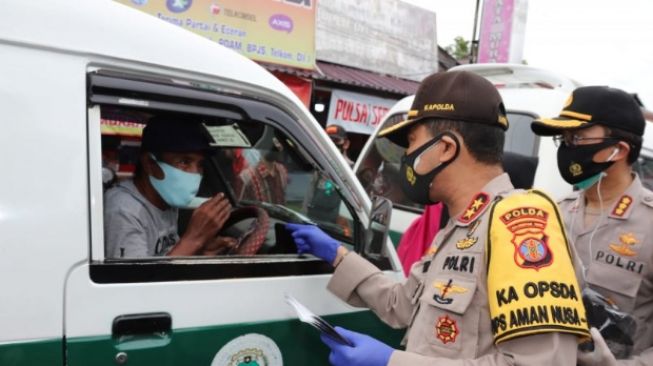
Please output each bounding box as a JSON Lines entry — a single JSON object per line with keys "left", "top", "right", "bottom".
{"left": 413, "top": 276, "right": 479, "bottom": 358}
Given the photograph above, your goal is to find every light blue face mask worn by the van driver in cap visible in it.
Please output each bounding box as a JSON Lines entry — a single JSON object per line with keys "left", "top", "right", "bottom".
{"left": 150, "top": 155, "right": 202, "bottom": 208}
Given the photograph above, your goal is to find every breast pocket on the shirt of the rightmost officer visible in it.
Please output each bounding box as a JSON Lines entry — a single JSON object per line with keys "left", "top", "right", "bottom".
{"left": 587, "top": 262, "right": 642, "bottom": 312}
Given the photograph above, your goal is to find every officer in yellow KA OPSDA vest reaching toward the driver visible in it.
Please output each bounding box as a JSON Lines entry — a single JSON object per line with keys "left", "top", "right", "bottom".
{"left": 287, "top": 71, "right": 589, "bottom": 366}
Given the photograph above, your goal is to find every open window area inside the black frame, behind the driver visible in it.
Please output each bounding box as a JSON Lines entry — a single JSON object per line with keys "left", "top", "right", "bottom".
{"left": 101, "top": 106, "right": 354, "bottom": 259}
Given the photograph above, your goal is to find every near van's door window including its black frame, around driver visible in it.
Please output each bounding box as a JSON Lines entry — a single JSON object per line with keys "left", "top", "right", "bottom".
{"left": 89, "top": 73, "right": 389, "bottom": 283}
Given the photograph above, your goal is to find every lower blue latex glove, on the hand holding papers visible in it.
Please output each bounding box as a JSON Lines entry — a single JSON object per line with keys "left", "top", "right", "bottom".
{"left": 320, "top": 327, "right": 394, "bottom": 366}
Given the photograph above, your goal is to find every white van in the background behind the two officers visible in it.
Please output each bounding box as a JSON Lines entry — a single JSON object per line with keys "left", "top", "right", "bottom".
{"left": 354, "top": 64, "right": 653, "bottom": 245}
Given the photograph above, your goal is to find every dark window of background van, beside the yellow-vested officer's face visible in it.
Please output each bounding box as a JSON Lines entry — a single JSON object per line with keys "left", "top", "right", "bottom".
{"left": 356, "top": 113, "right": 424, "bottom": 213}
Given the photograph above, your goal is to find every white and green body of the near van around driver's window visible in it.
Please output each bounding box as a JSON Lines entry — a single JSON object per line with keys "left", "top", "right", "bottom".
{"left": 0, "top": 0, "right": 402, "bottom": 365}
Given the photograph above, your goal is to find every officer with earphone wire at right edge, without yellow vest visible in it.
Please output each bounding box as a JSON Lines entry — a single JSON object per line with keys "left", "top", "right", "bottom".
{"left": 531, "top": 86, "right": 653, "bottom": 365}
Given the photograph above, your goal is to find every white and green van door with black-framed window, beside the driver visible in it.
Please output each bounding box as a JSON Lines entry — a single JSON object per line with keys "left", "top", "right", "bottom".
{"left": 65, "top": 70, "right": 401, "bottom": 366}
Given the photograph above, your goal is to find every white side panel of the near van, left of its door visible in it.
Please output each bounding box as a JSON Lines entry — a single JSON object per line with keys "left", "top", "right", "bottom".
{"left": 0, "top": 43, "right": 89, "bottom": 342}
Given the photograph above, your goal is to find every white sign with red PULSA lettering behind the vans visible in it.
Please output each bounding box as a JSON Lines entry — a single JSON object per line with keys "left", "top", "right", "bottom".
{"left": 327, "top": 90, "right": 396, "bottom": 135}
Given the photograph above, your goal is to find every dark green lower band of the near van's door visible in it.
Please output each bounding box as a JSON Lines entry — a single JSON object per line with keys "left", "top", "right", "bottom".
{"left": 68, "top": 309, "right": 405, "bottom": 366}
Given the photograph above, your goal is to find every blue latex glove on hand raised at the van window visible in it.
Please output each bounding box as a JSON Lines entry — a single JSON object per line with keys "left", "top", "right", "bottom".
{"left": 286, "top": 224, "right": 340, "bottom": 264}
